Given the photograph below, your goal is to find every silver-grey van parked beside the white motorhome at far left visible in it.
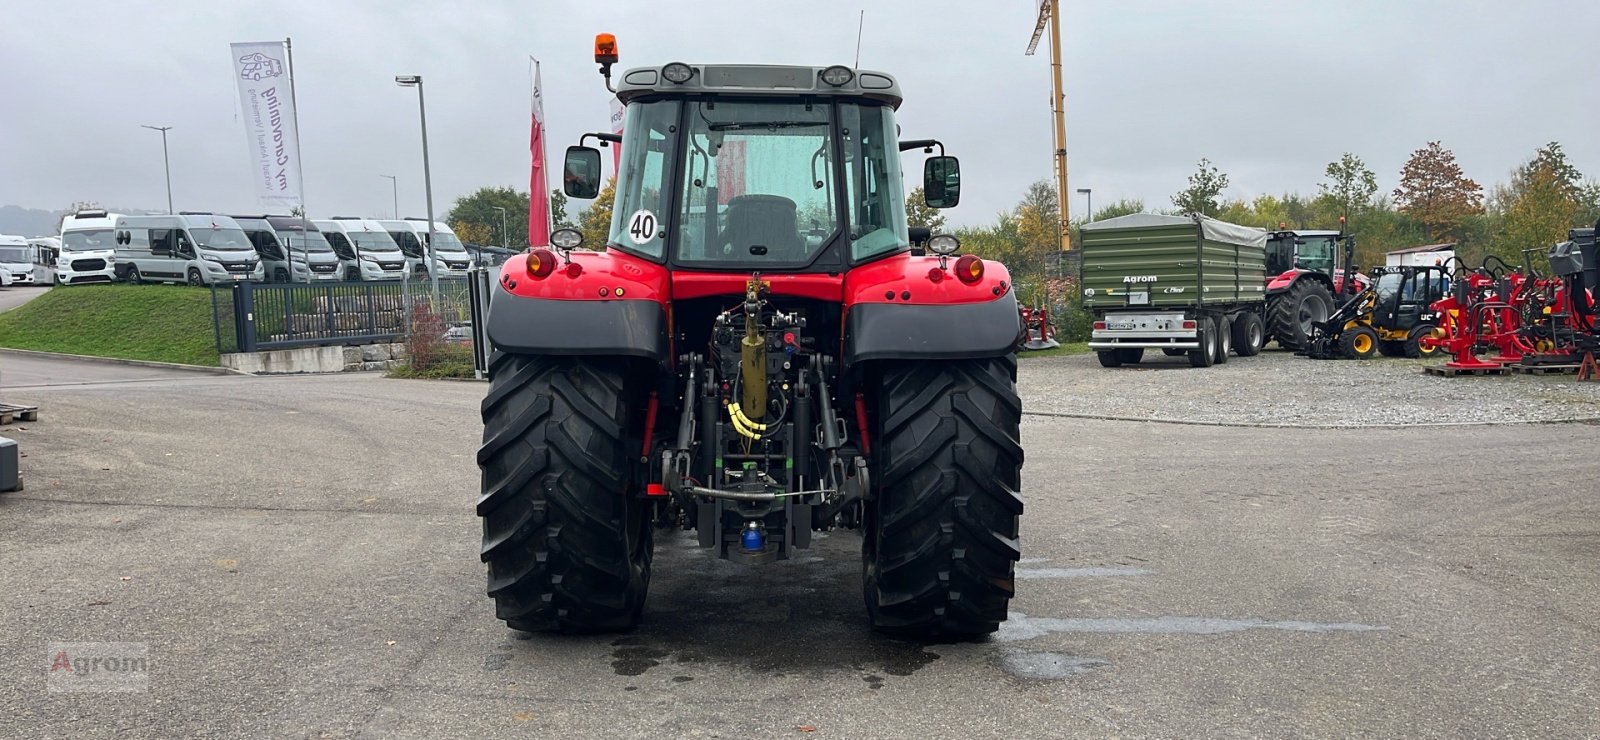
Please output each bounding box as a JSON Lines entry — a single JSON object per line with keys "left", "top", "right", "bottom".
{"left": 115, "top": 213, "right": 266, "bottom": 285}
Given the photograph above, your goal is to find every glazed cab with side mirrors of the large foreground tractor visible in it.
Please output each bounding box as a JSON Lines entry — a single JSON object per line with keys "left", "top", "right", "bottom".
{"left": 563, "top": 62, "right": 960, "bottom": 274}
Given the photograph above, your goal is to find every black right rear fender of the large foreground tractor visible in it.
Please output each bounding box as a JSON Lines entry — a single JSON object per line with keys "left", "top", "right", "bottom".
{"left": 845, "top": 292, "right": 1026, "bottom": 364}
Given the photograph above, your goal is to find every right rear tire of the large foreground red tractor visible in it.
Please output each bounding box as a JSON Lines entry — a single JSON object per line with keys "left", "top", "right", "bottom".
{"left": 862, "top": 356, "right": 1022, "bottom": 639}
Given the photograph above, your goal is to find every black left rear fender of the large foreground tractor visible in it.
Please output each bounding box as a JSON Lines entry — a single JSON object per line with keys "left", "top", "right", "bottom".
{"left": 486, "top": 280, "right": 670, "bottom": 365}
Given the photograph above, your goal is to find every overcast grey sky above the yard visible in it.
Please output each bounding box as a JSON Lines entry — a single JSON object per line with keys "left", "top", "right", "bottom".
{"left": 0, "top": 0, "right": 1600, "bottom": 224}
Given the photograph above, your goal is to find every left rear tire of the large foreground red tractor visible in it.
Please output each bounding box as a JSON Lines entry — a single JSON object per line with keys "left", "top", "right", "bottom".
{"left": 477, "top": 354, "right": 653, "bottom": 633}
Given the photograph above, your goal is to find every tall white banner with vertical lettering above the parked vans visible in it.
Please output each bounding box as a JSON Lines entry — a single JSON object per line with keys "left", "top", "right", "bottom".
{"left": 230, "top": 42, "right": 304, "bottom": 205}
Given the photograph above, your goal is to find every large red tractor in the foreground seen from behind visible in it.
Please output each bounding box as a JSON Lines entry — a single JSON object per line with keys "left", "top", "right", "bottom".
{"left": 477, "top": 38, "right": 1022, "bottom": 637}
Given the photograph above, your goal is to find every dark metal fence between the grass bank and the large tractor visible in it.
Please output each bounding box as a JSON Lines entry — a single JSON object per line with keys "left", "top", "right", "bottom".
{"left": 211, "top": 277, "right": 472, "bottom": 352}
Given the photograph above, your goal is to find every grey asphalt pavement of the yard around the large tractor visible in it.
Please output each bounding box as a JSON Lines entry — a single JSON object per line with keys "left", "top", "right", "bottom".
{"left": 0, "top": 358, "right": 1600, "bottom": 738}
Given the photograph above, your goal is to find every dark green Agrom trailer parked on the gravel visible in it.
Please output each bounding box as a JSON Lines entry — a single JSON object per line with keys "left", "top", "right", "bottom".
{"left": 1078, "top": 213, "right": 1267, "bottom": 367}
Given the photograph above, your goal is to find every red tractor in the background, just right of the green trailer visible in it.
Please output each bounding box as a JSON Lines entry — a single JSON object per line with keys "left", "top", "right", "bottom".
{"left": 1267, "top": 227, "right": 1368, "bottom": 349}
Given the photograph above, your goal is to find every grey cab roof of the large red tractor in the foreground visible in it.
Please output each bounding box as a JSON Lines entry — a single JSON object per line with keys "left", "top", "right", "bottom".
{"left": 616, "top": 64, "right": 904, "bottom": 107}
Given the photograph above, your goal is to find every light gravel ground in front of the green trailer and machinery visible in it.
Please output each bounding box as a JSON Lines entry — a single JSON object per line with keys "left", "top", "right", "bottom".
{"left": 1018, "top": 349, "right": 1600, "bottom": 426}
